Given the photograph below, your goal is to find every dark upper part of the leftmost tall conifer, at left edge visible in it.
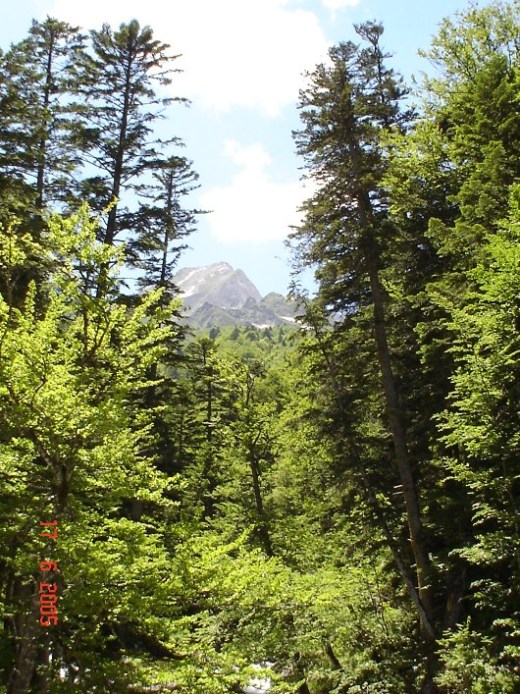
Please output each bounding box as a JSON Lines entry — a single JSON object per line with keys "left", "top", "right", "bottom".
{"left": 0, "top": 18, "right": 84, "bottom": 308}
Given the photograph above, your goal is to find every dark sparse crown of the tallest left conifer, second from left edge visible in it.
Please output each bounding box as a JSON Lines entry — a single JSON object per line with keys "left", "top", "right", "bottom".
{"left": 71, "top": 20, "right": 185, "bottom": 250}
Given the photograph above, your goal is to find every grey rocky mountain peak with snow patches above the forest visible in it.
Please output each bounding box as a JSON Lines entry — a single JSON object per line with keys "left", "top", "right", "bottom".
{"left": 173, "top": 262, "right": 297, "bottom": 328}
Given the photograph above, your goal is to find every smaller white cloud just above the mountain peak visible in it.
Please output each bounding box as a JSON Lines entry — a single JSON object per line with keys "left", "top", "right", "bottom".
{"left": 201, "top": 140, "right": 311, "bottom": 244}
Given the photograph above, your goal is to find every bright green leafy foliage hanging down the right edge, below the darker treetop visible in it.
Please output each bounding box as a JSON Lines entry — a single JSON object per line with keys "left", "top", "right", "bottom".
{"left": 430, "top": 187, "right": 520, "bottom": 656}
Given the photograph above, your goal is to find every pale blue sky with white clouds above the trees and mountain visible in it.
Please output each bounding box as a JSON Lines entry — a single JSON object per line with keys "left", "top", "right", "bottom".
{"left": 0, "top": 0, "right": 487, "bottom": 295}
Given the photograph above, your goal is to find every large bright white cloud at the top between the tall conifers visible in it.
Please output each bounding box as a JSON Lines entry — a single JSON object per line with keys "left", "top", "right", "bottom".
{"left": 47, "top": 0, "right": 330, "bottom": 116}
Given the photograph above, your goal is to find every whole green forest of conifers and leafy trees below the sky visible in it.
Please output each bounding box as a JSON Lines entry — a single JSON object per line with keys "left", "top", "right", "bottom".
{"left": 0, "top": 0, "right": 520, "bottom": 694}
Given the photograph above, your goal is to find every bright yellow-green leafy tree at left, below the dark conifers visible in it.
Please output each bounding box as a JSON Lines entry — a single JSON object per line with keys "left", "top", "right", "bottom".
{"left": 0, "top": 208, "right": 184, "bottom": 687}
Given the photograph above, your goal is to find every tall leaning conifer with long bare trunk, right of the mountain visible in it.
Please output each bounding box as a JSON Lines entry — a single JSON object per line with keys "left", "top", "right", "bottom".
{"left": 293, "top": 23, "right": 435, "bottom": 656}
